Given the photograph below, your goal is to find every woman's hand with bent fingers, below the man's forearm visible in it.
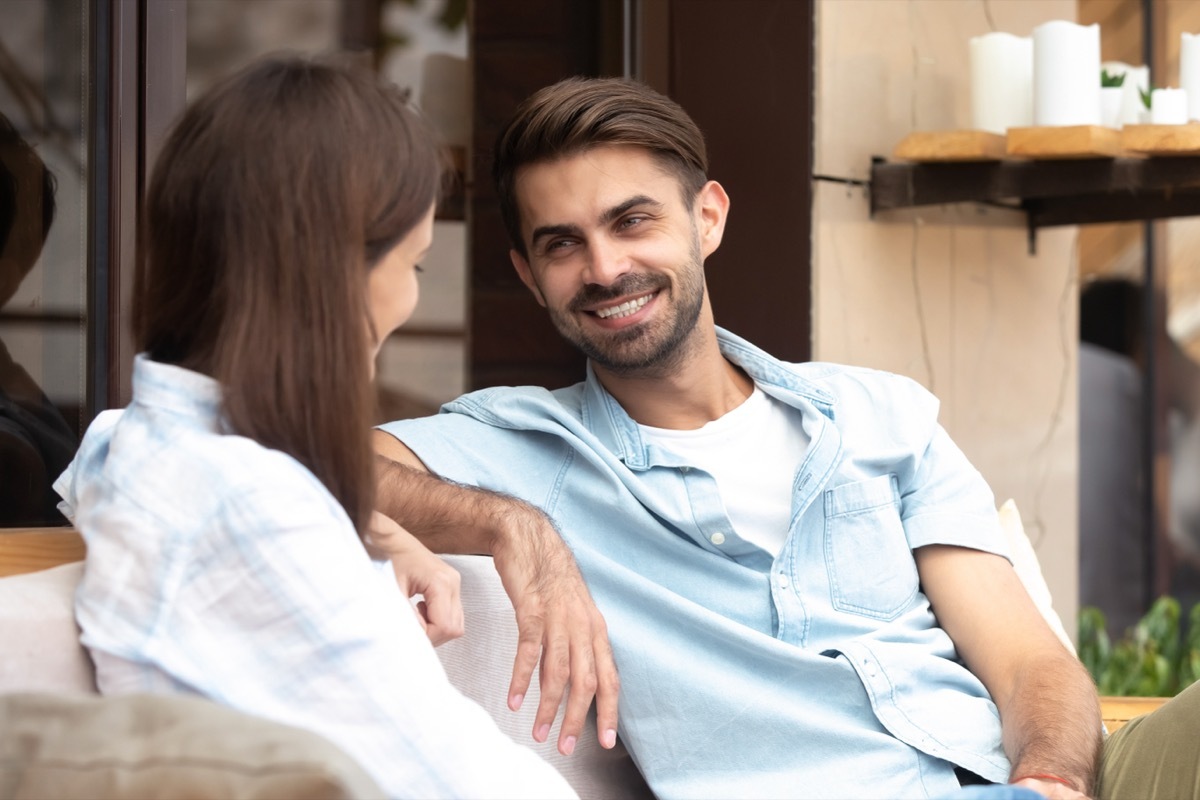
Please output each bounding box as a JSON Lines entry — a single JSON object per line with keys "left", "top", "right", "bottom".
{"left": 370, "top": 511, "right": 463, "bottom": 646}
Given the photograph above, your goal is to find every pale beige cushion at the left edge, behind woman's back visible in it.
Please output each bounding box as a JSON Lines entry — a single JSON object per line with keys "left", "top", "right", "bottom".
{"left": 0, "top": 561, "right": 96, "bottom": 693}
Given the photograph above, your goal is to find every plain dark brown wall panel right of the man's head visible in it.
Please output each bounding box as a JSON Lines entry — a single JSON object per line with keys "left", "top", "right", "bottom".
{"left": 670, "top": 0, "right": 814, "bottom": 361}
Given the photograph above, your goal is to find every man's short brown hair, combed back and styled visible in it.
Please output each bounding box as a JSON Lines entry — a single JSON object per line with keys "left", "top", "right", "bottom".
{"left": 492, "top": 77, "right": 708, "bottom": 257}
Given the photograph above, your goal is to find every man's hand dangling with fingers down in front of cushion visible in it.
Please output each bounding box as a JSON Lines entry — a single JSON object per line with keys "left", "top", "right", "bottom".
{"left": 492, "top": 510, "right": 620, "bottom": 756}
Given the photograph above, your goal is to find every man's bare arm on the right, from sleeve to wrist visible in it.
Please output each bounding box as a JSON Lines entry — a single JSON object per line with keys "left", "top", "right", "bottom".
{"left": 916, "top": 546, "right": 1100, "bottom": 798}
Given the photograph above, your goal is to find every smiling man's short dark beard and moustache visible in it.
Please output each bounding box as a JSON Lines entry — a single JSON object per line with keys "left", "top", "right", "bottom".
{"left": 550, "top": 240, "right": 704, "bottom": 377}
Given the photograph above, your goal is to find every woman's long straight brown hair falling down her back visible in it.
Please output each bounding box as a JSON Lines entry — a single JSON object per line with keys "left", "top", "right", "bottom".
{"left": 132, "top": 56, "right": 444, "bottom": 534}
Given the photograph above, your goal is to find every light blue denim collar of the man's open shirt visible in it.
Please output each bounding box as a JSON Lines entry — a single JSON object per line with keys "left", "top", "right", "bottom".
{"left": 583, "top": 326, "right": 835, "bottom": 469}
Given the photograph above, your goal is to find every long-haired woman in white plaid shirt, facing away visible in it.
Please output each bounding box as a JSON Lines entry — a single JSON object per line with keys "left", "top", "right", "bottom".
{"left": 56, "top": 59, "right": 571, "bottom": 798}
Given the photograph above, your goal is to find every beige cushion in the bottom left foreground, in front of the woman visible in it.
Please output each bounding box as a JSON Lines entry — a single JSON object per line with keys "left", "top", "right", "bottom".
{"left": 0, "top": 693, "right": 383, "bottom": 800}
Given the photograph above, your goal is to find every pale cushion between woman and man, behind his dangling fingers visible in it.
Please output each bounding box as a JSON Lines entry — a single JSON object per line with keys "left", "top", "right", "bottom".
{"left": 438, "top": 555, "right": 654, "bottom": 800}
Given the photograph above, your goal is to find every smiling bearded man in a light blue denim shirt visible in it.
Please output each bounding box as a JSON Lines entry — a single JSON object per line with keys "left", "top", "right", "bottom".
{"left": 377, "top": 79, "right": 1190, "bottom": 798}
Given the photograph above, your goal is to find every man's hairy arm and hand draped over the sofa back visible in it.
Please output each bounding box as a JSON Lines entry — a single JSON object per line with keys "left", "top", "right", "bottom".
{"left": 372, "top": 431, "right": 620, "bottom": 756}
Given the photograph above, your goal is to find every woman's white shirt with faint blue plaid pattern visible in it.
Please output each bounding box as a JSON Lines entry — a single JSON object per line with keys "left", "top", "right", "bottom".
{"left": 55, "top": 356, "right": 574, "bottom": 798}
